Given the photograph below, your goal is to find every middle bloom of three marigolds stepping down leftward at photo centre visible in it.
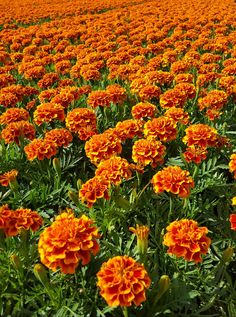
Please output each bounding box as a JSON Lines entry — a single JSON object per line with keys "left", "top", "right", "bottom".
{"left": 95, "top": 156, "right": 132, "bottom": 185}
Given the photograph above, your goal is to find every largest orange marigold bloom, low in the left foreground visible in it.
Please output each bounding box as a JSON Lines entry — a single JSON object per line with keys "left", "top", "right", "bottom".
{"left": 38, "top": 210, "right": 100, "bottom": 274}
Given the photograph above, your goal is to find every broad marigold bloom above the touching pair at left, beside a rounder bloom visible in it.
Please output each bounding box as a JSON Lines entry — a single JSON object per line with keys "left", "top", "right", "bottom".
{"left": 34, "top": 102, "right": 65, "bottom": 125}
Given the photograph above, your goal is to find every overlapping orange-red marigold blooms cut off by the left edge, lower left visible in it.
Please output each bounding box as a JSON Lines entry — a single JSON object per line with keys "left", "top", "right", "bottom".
{"left": 0, "top": 205, "right": 43, "bottom": 237}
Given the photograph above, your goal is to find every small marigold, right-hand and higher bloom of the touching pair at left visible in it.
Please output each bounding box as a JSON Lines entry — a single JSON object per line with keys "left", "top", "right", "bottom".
{"left": 44, "top": 128, "right": 73, "bottom": 147}
